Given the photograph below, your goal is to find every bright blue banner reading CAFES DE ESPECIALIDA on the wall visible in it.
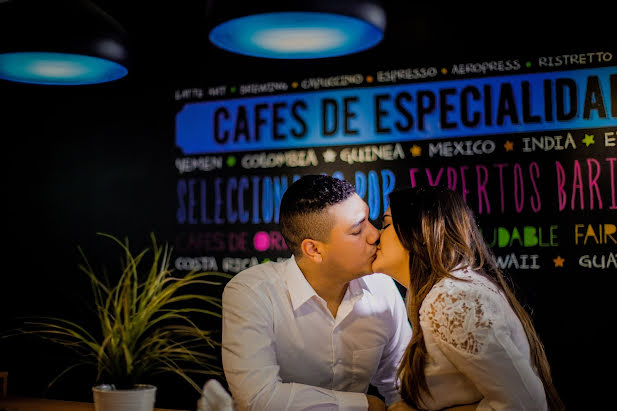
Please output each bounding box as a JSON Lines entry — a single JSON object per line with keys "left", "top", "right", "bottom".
{"left": 176, "top": 67, "right": 617, "bottom": 154}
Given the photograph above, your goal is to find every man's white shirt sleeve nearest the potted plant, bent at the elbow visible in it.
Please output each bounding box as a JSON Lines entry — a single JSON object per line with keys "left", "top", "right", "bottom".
{"left": 221, "top": 282, "right": 368, "bottom": 411}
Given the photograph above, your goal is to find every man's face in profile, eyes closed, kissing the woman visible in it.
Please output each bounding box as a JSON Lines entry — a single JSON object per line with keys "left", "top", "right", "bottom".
{"left": 323, "top": 194, "right": 379, "bottom": 281}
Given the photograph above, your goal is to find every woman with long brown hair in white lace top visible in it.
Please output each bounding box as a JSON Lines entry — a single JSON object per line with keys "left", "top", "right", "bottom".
{"left": 373, "top": 186, "right": 564, "bottom": 410}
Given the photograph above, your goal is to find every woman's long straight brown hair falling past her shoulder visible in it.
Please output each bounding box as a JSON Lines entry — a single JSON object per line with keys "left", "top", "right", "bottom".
{"left": 390, "top": 186, "right": 565, "bottom": 411}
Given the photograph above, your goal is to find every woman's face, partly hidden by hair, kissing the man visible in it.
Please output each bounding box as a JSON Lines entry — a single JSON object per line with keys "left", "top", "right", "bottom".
{"left": 373, "top": 207, "right": 409, "bottom": 288}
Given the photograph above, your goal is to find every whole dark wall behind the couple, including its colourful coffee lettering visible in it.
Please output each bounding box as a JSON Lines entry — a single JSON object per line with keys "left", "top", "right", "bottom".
{"left": 0, "top": 2, "right": 617, "bottom": 409}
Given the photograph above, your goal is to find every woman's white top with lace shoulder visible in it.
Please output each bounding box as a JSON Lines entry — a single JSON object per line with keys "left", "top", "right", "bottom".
{"left": 420, "top": 270, "right": 547, "bottom": 410}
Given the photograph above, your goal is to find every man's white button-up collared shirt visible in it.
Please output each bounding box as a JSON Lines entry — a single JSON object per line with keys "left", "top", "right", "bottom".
{"left": 222, "top": 257, "right": 411, "bottom": 411}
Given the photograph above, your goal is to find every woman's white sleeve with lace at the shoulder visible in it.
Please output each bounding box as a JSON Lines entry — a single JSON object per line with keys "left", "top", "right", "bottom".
{"left": 421, "top": 290, "right": 547, "bottom": 411}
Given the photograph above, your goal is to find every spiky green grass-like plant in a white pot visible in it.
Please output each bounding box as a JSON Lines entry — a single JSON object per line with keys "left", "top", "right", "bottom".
{"left": 4, "top": 233, "right": 231, "bottom": 411}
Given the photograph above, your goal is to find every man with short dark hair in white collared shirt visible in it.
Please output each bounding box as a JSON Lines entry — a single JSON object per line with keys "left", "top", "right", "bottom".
{"left": 222, "top": 175, "right": 411, "bottom": 411}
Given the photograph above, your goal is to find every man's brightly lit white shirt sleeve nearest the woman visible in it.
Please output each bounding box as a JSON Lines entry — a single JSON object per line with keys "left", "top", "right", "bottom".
{"left": 371, "top": 277, "right": 411, "bottom": 405}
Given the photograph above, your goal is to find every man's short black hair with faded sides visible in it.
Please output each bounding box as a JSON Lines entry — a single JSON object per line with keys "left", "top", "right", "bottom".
{"left": 279, "top": 174, "right": 356, "bottom": 256}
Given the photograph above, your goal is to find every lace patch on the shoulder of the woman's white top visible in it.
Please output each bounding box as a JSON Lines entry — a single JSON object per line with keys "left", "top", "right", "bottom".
{"left": 420, "top": 280, "right": 495, "bottom": 354}
